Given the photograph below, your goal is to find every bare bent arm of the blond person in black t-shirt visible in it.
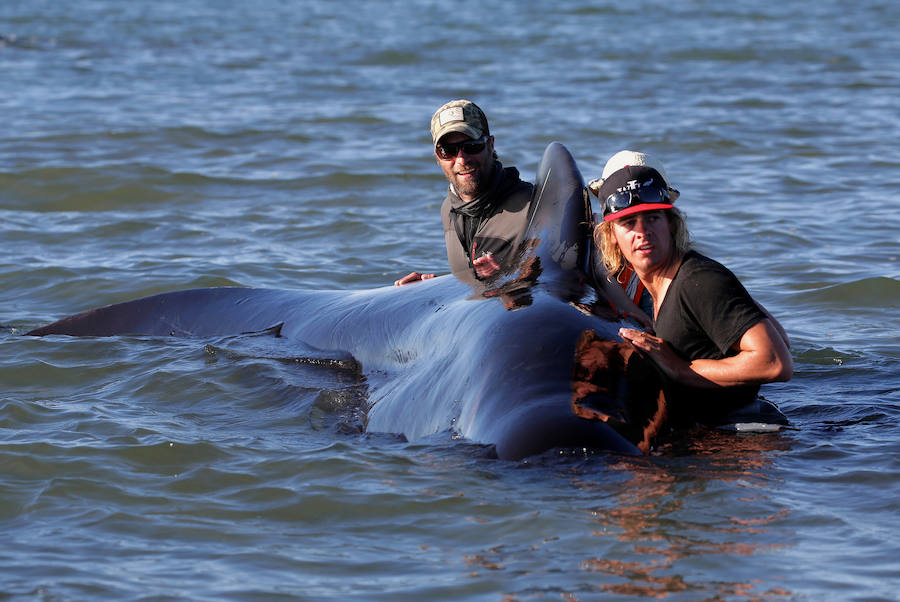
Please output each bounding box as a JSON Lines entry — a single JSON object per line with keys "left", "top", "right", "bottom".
{"left": 619, "top": 319, "right": 794, "bottom": 388}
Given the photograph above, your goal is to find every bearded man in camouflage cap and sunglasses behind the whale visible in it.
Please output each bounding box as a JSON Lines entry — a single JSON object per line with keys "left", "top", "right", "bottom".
{"left": 394, "top": 100, "right": 533, "bottom": 286}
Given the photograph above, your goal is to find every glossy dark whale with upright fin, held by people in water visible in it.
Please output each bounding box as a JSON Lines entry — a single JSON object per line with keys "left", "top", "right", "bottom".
{"left": 28, "top": 143, "right": 664, "bottom": 460}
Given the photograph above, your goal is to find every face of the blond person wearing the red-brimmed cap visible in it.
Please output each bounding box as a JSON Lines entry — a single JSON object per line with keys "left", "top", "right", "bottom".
{"left": 612, "top": 211, "right": 673, "bottom": 274}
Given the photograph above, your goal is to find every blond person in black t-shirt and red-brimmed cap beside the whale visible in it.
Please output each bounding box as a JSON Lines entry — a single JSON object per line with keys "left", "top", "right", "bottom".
{"left": 590, "top": 151, "right": 793, "bottom": 422}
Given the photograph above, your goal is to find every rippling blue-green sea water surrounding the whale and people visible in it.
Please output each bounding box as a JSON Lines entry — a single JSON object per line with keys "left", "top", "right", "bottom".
{"left": 0, "top": 0, "right": 900, "bottom": 601}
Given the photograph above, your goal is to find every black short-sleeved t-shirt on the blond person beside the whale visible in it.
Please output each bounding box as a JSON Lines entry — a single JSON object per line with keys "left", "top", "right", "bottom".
{"left": 654, "top": 251, "right": 766, "bottom": 422}
